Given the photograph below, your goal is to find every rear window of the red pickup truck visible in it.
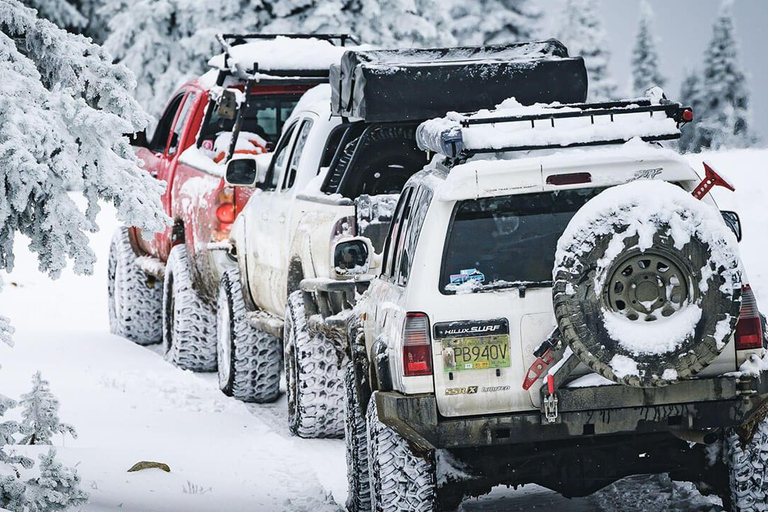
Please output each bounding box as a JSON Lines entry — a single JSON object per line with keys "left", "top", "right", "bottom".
{"left": 201, "top": 94, "right": 301, "bottom": 150}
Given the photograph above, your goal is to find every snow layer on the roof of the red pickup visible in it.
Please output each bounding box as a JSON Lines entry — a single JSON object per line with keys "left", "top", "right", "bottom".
{"left": 208, "top": 36, "right": 350, "bottom": 72}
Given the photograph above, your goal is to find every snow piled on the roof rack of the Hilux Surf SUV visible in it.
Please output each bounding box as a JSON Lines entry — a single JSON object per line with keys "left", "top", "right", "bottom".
{"left": 418, "top": 98, "right": 680, "bottom": 156}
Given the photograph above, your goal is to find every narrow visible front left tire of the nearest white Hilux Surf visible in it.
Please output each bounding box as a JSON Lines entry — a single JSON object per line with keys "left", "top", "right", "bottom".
{"left": 344, "top": 364, "right": 371, "bottom": 512}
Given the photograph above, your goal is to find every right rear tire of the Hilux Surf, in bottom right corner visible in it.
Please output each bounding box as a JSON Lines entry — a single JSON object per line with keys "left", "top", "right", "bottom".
{"left": 724, "top": 418, "right": 768, "bottom": 512}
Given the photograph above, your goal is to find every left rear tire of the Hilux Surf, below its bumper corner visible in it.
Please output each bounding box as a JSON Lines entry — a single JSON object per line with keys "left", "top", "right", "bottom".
{"left": 366, "top": 392, "right": 437, "bottom": 512}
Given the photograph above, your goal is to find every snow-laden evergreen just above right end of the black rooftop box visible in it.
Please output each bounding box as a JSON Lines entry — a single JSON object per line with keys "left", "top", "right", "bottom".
{"left": 555, "top": 0, "right": 617, "bottom": 101}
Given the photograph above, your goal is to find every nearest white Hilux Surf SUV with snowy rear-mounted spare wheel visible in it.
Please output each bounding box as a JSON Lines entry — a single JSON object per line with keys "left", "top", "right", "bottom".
{"left": 336, "top": 94, "right": 768, "bottom": 512}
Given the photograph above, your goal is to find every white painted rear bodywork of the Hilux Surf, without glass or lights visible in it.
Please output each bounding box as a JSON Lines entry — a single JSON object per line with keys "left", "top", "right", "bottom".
{"left": 361, "top": 147, "right": 759, "bottom": 417}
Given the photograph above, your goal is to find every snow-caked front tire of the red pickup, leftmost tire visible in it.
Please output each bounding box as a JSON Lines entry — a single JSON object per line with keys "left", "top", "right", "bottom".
{"left": 107, "top": 227, "right": 163, "bottom": 345}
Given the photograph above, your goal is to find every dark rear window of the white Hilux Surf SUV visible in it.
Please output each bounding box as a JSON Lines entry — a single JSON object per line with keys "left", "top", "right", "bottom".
{"left": 440, "top": 188, "right": 604, "bottom": 293}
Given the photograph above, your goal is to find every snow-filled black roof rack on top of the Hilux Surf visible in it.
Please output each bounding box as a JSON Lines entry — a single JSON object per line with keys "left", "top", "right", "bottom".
{"left": 416, "top": 89, "right": 693, "bottom": 158}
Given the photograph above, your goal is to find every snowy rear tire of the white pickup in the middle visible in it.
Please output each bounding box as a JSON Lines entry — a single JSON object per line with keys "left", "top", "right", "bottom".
{"left": 283, "top": 290, "right": 344, "bottom": 438}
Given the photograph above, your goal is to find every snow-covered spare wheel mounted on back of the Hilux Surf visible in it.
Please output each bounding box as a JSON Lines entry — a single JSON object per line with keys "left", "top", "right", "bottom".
{"left": 553, "top": 181, "right": 741, "bottom": 387}
